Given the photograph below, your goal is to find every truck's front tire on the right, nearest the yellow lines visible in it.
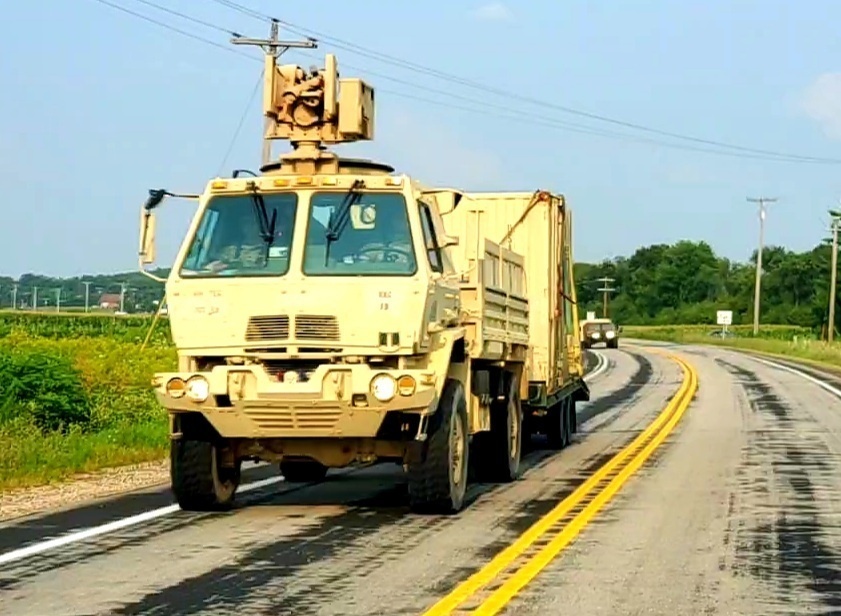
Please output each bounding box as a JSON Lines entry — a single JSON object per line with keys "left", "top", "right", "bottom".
{"left": 407, "top": 379, "right": 469, "bottom": 514}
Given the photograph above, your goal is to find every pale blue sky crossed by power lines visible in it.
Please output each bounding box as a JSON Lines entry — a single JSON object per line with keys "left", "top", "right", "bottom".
{"left": 0, "top": 0, "right": 841, "bottom": 277}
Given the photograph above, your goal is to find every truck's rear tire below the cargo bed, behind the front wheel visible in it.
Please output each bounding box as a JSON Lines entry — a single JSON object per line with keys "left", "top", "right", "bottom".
{"left": 473, "top": 378, "right": 523, "bottom": 483}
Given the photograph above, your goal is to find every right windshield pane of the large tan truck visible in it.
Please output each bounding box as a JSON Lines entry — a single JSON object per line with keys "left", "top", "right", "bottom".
{"left": 303, "top": 192, "right": 417, "bottom": 276}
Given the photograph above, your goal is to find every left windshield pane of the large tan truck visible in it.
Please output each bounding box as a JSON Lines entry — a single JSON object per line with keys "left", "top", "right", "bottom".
{"left": 180, "top": 193, "right": 298, "bottom": 278}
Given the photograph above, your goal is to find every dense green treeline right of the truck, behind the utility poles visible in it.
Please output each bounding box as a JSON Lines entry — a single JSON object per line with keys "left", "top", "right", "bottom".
{"left": 575, "top": 241, "right": 841, "bottom": 332}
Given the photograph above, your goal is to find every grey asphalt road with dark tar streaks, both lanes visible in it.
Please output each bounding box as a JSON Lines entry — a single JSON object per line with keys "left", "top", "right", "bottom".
{"left": 0, "top": 344, "right": 841, "bottom": 616}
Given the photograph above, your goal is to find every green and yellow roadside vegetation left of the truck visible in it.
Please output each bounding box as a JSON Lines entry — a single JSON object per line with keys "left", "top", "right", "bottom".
{"left": 0, "top": 312, "right": 175, "bottom": 490}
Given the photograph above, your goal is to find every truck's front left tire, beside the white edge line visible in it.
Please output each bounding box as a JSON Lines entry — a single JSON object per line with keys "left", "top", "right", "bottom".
{"left": 170, "top": 439, "right": 241, "bottom": 511}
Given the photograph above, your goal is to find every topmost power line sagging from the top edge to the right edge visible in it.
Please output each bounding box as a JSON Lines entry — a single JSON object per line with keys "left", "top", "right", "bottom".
{"left": 205, "top": 0, "right": 841, "bottom": 164}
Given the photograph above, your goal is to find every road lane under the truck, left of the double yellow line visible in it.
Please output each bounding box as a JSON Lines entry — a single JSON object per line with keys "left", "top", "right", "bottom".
{"left": 0, "top": 349, "right": 680, "bottom": 615}
